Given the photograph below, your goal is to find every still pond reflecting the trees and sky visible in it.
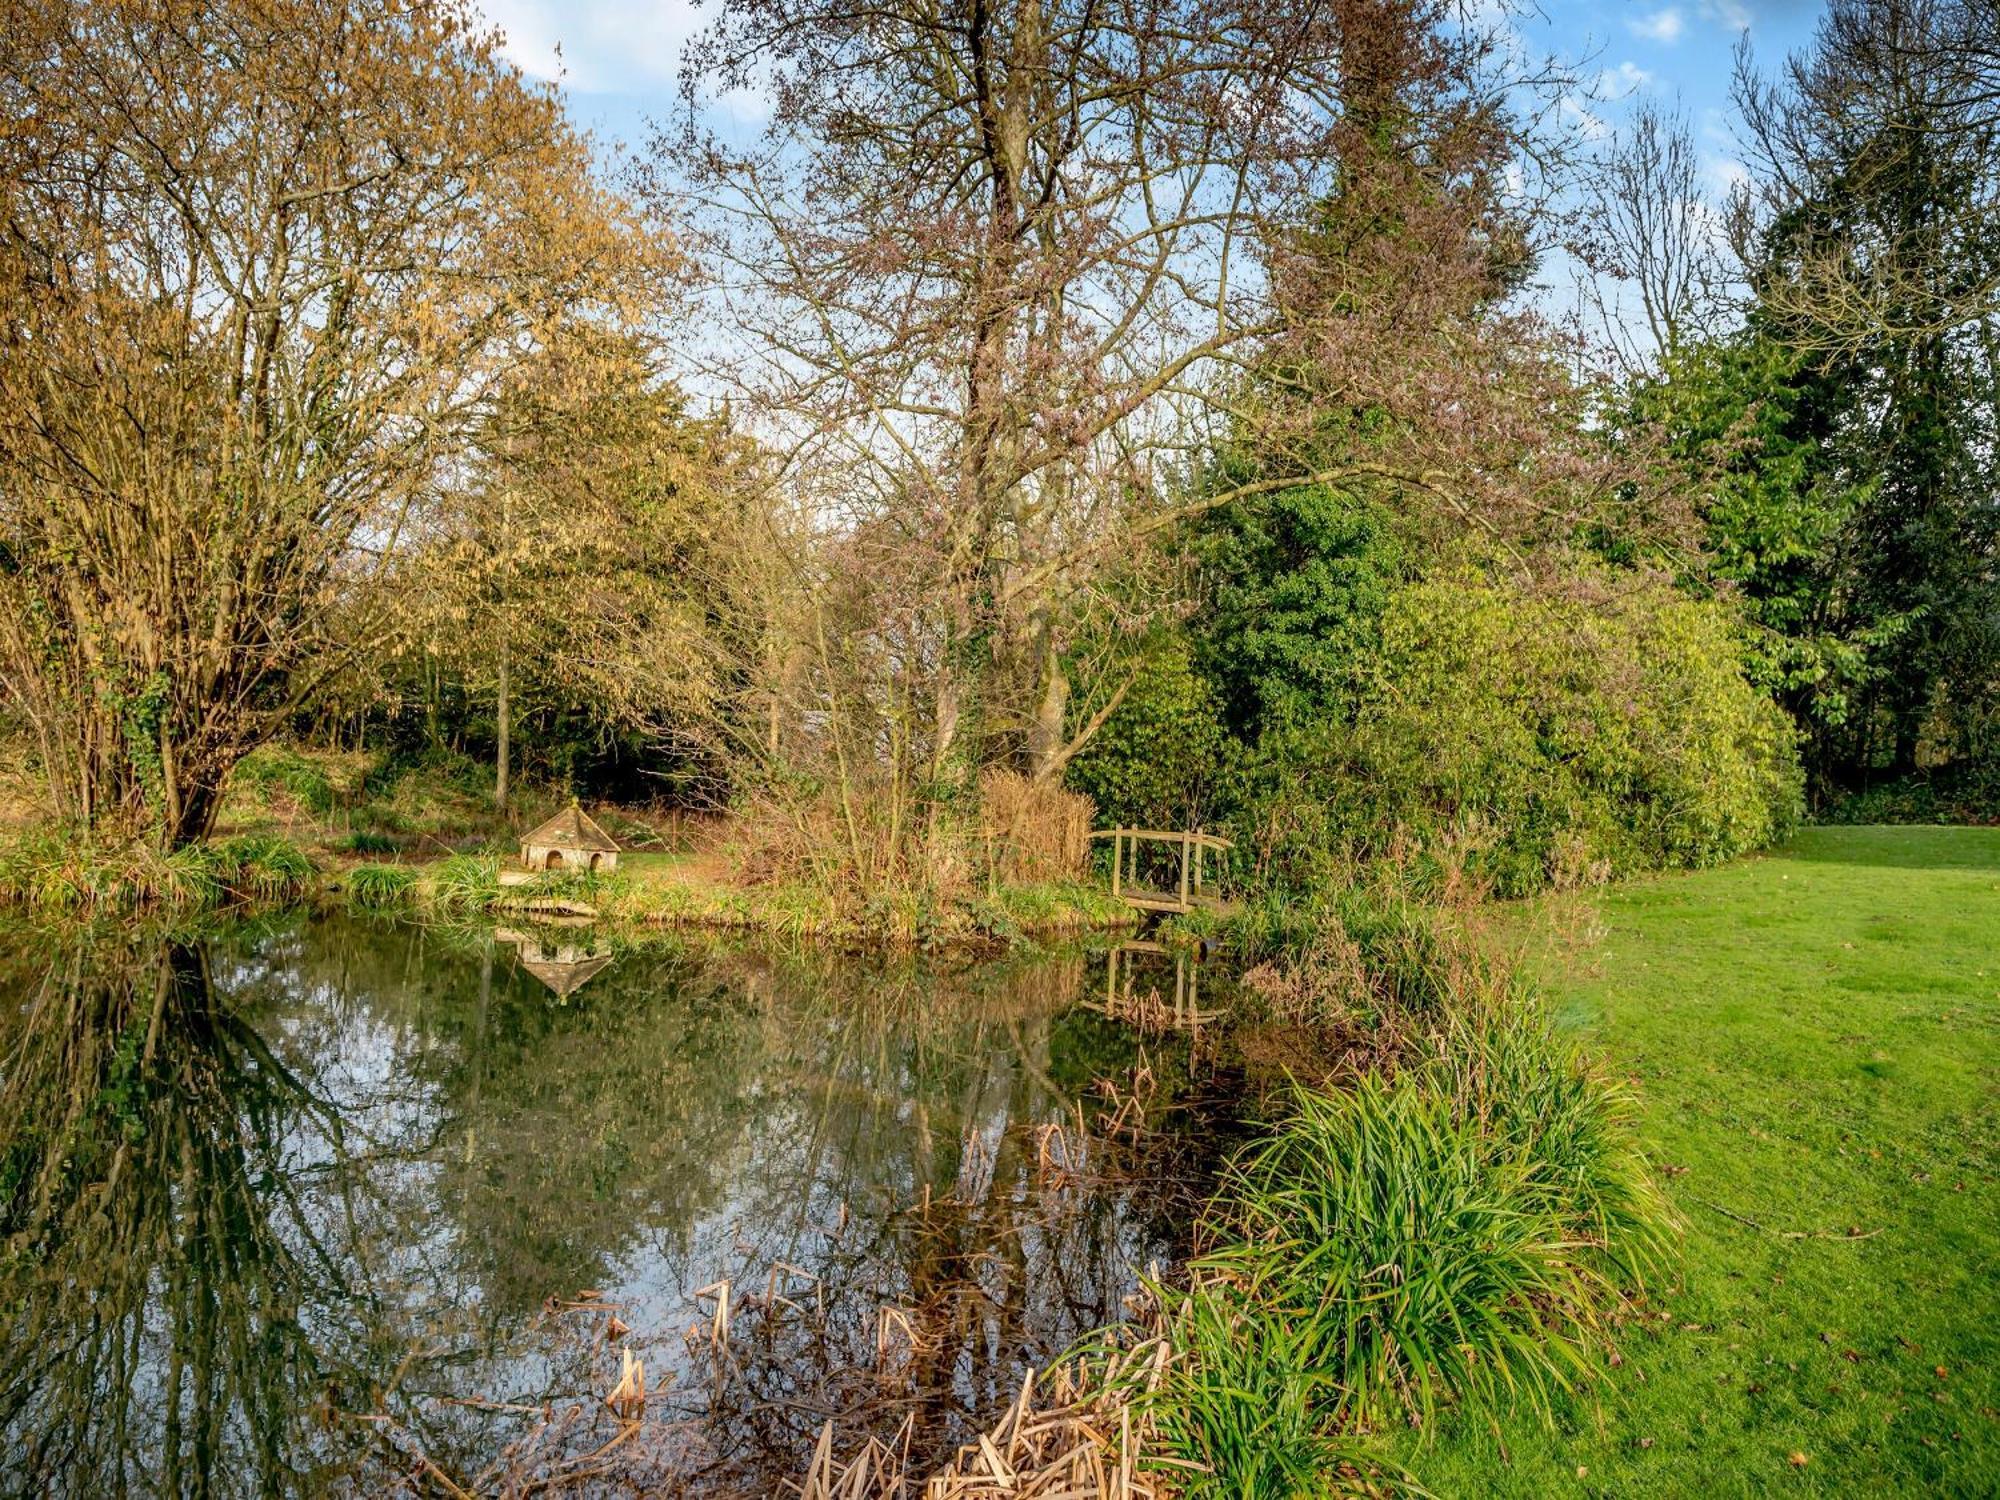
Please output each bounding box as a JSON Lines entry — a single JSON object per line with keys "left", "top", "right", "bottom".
{"left": 0, "top": 916, "right": 1230, "bottom": 1496}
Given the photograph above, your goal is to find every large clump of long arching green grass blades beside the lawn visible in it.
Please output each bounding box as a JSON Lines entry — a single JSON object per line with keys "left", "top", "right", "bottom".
{"left": 1158, "top": 994, "right": 1672, "bottom": 1496}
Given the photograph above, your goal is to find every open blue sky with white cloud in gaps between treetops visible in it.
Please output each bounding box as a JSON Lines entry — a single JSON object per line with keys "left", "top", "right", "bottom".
{"left": 478, "top": 0, "right": 1820, "bottom": 184}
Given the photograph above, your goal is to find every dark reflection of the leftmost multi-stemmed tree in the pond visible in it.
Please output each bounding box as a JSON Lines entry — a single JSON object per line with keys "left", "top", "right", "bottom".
{"left": 0, "top": 942, "right": 354, "bottom": 1494}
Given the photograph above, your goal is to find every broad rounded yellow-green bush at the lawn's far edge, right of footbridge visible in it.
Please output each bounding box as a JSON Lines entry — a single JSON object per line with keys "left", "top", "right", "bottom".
{"left": 1242, "top": 570, "right": 1798, "bottom": 894}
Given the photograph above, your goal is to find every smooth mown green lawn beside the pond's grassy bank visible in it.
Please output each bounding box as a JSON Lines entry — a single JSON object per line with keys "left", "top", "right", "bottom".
{"left": 1400, "top": 828, "right": 2000, "bottom": 1500}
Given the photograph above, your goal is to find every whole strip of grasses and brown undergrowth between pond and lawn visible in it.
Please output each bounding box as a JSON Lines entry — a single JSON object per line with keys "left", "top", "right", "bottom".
{"left": 1148, "top": 878, "right": 1674, "bottom": 1500}
